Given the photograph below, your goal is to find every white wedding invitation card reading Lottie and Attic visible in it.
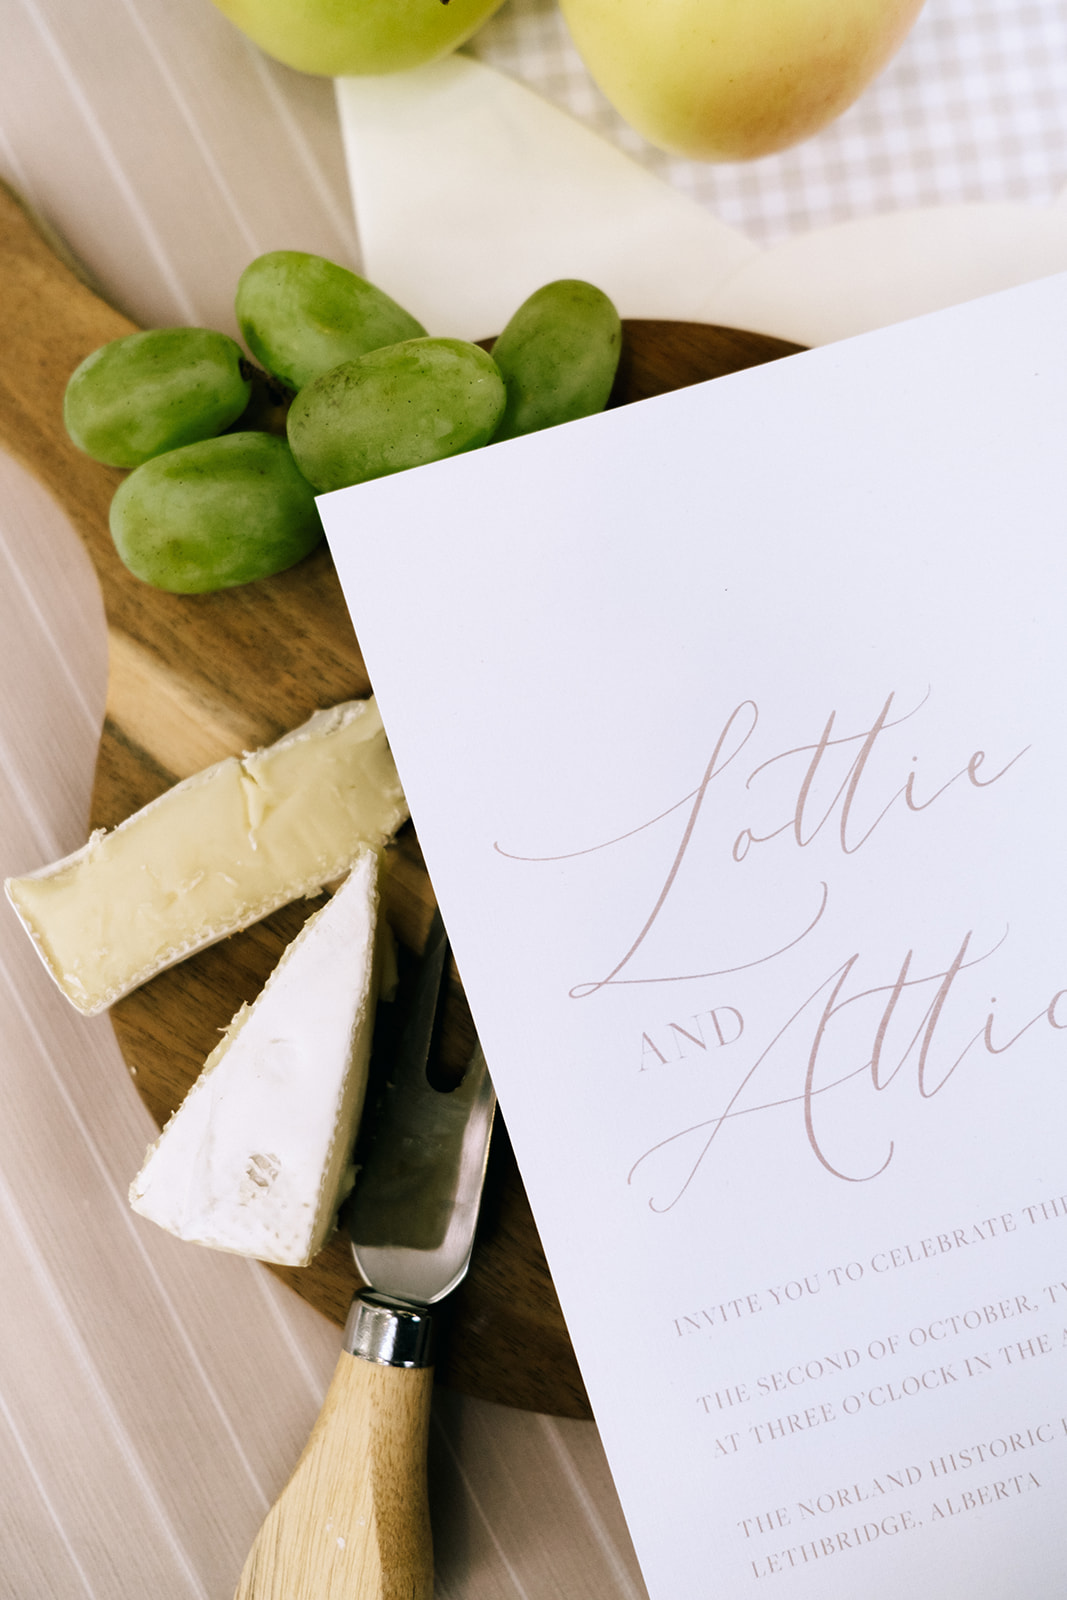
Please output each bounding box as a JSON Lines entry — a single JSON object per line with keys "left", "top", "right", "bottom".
{"left": 320, "top": 268, "right": 1067, "bottom": 1600}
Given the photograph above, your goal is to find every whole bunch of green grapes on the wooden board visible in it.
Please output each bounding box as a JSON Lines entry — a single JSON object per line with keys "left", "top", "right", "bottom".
{"left": 64, "top": 250, "right": 621, "bottom": 594}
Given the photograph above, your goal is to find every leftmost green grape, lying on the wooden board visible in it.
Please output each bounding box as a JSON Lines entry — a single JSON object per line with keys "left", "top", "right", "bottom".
{"left": 62, "top": 328, "right": 251, "bottom": 467}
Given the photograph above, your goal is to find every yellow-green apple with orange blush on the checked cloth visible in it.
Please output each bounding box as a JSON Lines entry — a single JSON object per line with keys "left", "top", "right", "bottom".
{"left": 560, "top": 0, "right": 923, "bottom": 162}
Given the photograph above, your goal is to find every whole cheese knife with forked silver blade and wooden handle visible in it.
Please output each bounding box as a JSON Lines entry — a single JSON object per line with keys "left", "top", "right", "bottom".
{"left": 235, "top": 912, "right": 496, "bottom": 1600}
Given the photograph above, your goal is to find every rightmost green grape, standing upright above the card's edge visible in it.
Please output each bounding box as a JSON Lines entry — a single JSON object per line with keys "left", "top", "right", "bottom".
{"left": 493, "top": 278, "right": 622, "bottom": 440}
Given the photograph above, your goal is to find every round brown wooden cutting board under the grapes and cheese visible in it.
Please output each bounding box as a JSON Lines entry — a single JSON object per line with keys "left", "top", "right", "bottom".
{"left": 0, "top": 189, "right": 797, "bottom": 1416}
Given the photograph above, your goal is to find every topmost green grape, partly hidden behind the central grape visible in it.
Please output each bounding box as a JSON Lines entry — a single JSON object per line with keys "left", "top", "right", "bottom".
{"left": 237, "top": 250, "right": 426, "bottom": 389}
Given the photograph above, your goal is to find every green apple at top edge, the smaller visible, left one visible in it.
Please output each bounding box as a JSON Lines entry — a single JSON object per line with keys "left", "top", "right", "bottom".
{"left": 214, "top": 0, "right": 502, "bottom": 77}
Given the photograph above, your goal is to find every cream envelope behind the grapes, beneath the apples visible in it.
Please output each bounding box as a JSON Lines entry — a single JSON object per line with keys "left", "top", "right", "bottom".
{"left": 336, "top": 56, "right": 1067, "bottom": 344}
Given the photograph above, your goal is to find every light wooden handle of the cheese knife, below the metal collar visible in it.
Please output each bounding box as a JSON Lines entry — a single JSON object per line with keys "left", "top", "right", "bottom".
{"left": 235, "top": 1350, "right": 434, "bottom": 1600}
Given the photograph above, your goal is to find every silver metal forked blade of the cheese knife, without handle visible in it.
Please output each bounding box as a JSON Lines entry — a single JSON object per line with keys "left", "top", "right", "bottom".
{"left": 347, "top": 914, "right": 496, "bottom": 1306}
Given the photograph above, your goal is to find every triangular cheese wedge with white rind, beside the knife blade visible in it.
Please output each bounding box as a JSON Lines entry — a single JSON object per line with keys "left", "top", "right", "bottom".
{"left": 130, "top": 851, "right": 378, "bottom": 1267}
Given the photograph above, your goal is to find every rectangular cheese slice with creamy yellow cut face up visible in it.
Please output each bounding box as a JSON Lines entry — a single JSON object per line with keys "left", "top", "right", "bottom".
{"left": 5, "top": 699, "right": 408, "bottom": 1016}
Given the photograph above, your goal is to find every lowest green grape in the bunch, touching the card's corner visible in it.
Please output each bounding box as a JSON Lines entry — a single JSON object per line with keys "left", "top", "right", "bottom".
{"left": 110, "top": 434, "right": 322, "bottom": 595}
